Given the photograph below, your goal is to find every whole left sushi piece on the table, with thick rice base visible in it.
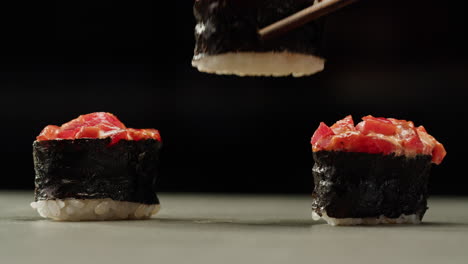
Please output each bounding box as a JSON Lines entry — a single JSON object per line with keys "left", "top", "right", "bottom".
{"left": 31, "top": 112, "right": 161, "bottom": 221}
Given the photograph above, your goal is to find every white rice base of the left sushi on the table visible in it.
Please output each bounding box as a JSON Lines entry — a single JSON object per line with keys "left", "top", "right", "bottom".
{"left": 31, "top": 198, "right": 161, "bottom": 221}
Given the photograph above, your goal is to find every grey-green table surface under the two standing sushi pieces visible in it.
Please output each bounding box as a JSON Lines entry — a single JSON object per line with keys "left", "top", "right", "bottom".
{"left": 0, "top": 192, "right": 468, "bottom": 264}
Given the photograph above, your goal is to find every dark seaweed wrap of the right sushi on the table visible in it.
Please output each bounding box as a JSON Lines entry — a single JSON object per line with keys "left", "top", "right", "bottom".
{"left": 312, "top": 151, "right": 431, "bottom": 219}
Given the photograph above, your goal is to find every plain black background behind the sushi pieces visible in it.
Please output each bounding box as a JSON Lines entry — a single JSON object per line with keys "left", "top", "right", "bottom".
{"left": 0, "top": 0, "right": 468, "bottom": 194}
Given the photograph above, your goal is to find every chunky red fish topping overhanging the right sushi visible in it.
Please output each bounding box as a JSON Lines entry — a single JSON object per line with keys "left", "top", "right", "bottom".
{"left": 311, "top": 115, "right": 447, "bottom": 164}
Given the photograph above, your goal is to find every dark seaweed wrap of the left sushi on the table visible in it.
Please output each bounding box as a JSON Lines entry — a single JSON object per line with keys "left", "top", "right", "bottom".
{"left": 33, "top": 138, "right": 161, "bottom": 204}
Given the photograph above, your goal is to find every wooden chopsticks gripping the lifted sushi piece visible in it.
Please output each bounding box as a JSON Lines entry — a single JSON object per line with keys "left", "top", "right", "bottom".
{"left": 258, "top": 0, "right": 357, "bottom": 40}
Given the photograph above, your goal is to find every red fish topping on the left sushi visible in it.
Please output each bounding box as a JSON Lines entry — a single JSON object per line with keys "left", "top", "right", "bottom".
{"left": 36, "top": 112, "right": 161, "bottom": 144}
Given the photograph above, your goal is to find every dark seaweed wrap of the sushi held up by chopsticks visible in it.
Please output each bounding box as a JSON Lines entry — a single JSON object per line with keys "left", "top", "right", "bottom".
{"left": 194, "top": 0, "right": 323, "bottom": 56}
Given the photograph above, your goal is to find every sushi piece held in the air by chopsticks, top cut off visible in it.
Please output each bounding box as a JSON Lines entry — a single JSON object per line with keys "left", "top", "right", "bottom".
{"left": 192, "top": 0, "right": 325, "bottom": 77}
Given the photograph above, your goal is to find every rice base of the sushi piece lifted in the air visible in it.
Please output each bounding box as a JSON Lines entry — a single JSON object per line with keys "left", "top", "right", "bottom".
{"left": 192, "top": 52, "right": 325, "bottom": 77}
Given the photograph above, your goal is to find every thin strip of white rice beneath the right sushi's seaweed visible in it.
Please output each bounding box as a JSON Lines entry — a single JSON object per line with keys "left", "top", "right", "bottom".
{"left": 312, "top": 212, "right": 421, "bottom": 226}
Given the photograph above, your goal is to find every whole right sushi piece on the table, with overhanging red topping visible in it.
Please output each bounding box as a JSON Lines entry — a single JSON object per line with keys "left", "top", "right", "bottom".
{"left": 311, "top": 116, "right": 447, "bottom": 225}
